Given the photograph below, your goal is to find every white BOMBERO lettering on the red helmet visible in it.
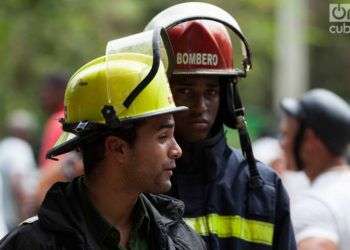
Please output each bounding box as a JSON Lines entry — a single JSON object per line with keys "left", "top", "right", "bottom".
{"left": 176, "top": 53, "right": 219, "bottom": 66}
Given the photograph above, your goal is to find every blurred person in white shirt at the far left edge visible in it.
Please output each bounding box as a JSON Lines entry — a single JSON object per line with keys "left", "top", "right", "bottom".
{"left": 0, "top": 110, "right": 37, "bottom": 229}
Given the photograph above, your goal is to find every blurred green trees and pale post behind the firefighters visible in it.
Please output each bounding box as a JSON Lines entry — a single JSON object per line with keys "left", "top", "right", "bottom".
{"left": 0, "top": 0, "right": 350, "bottom": 147}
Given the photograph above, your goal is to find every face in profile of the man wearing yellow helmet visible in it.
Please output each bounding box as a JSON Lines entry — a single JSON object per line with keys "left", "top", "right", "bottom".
{"left": 128, "top": 114, "right": 182, "bottom": 194}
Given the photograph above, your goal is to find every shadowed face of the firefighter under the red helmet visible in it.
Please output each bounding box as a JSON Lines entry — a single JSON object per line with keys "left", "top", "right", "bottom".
{"left": 170, "top": 75, "right": 220, "bottom": 142}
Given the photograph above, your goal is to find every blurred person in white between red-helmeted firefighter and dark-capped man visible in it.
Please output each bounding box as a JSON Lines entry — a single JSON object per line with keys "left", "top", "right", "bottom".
{"left": 253, "top": 137, "right": 310, "bottom": 204}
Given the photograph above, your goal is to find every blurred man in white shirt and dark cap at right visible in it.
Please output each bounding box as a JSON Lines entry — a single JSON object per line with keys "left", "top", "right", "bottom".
{"left": 281, "top": 89, "right": 350, "bottom": 250}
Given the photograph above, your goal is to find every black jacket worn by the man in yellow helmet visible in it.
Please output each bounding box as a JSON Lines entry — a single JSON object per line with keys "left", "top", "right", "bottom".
{"left": 0, "top": 179, "right": 205, "bottom": 250}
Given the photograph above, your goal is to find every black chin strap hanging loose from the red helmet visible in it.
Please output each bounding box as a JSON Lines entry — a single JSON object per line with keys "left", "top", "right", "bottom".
{"left": 229, "top": 78, "right": 263, "bottom": 189}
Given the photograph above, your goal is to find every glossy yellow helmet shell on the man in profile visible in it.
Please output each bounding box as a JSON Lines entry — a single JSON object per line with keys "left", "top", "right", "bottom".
{"left": 65, "top": 53, "right": 182, "bottom": 123}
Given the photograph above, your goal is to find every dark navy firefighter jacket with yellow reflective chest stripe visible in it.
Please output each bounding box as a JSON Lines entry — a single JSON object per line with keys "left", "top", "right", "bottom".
{"left": 169, "top": 131, "right": 296, "bottom": 250}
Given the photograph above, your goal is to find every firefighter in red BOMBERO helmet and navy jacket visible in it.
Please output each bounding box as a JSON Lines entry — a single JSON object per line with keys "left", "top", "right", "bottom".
{"left": 146, "top": 3, "right": 296, "bottom": 250}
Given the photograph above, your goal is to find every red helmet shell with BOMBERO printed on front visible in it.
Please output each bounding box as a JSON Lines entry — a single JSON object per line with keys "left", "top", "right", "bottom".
{"left": 167, "top": 20, "right": 233, "bottom": 75}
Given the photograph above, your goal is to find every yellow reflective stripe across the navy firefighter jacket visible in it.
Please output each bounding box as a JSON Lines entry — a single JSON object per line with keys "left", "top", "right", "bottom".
{"left": 184, "top": 214, "right": 274, "bottom": 245}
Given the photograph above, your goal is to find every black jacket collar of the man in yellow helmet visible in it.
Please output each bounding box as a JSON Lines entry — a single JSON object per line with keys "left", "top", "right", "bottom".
{"left": 38, "top": 177, "right": 184, "bottom": 249}
